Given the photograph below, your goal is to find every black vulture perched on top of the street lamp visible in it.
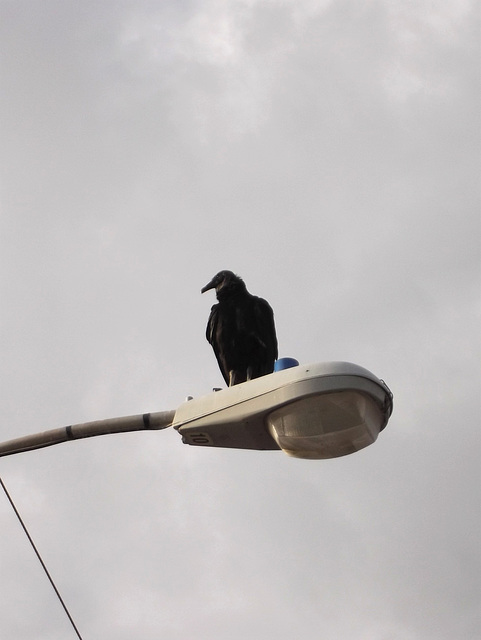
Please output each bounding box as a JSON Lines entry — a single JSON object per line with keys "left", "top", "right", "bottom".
{"left": 201, "top": 271, "right": 277, "bottom": 387}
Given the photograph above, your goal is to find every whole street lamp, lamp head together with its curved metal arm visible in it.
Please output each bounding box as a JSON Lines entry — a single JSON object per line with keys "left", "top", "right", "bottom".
{"left": 0, "top": 362, "right": 393, "bottom": 459}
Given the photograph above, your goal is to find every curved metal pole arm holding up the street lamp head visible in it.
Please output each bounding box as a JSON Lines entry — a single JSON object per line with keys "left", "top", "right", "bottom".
{"left": 0, "top": 411, "right": 175, "bottom": 457}
